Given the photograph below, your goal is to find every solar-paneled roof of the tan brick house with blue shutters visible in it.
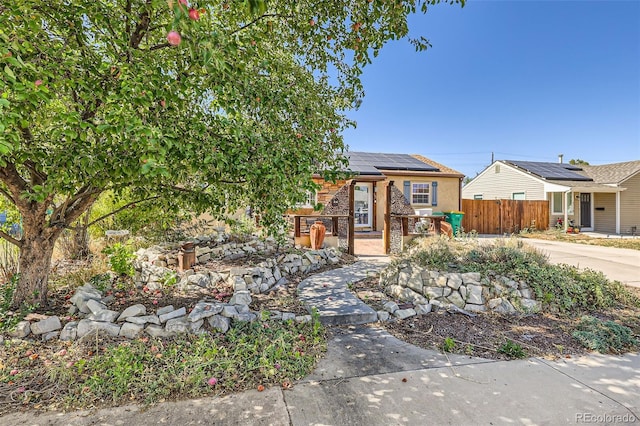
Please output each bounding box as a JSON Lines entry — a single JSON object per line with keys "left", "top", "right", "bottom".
{"left": 345, "top": 151, "right": 464, "bottom": 176}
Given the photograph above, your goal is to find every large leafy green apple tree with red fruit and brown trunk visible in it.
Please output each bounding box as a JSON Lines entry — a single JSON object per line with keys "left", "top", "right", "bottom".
{"left": 0, "top": 0, "right": 460, "bottom": 305}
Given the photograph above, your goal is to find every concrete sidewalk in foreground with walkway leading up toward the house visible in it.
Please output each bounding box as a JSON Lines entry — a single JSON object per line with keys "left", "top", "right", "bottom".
{"left": 0, "top": 259, "right": 640, "bottom": 426}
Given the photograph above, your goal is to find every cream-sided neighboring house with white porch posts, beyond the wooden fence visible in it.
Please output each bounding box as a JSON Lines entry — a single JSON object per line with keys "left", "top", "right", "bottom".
{"left": 462, "top": 157, "right": 640, "bottom": 234}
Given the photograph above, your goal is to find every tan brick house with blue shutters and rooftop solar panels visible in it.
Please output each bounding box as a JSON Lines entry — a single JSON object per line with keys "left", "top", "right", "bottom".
{"left": 297, "top": 152, "right": 464, "bottom": 231}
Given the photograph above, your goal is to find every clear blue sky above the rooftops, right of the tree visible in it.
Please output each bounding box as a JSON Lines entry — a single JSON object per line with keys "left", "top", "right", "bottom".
{"left": 344, "top": 0, "right": 640, "bottom": 177}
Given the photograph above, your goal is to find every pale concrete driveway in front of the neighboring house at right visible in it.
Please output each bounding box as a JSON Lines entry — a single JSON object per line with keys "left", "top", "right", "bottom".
{"left": 523, "top": 238, "right": 640, "bottom": 287}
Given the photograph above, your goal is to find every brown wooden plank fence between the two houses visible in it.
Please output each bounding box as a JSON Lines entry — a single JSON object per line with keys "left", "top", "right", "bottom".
{"left": 462, "top": 200, "right": 549, "bottom": 234}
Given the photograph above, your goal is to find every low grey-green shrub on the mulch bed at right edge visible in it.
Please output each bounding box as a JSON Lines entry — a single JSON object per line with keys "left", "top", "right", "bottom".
{"left": 573, "top": 315, "right": 639, "bottom": 353}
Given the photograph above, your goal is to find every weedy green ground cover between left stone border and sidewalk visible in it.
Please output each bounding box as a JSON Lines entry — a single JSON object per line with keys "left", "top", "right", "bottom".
{"left": 0, "top": 317, "right": 326, "bottom": 412}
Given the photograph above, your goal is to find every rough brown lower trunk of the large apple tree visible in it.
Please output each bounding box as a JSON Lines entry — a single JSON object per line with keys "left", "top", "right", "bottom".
{"left": 12, "top": 232, "right": 57, "bottom": 309}
